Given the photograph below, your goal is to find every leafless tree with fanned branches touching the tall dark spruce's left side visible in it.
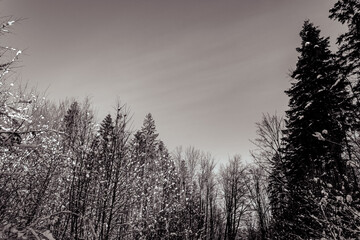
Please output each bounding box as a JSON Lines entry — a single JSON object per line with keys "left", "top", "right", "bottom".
{"left": 250, "top": 114, "right": 288, "bottom": 238}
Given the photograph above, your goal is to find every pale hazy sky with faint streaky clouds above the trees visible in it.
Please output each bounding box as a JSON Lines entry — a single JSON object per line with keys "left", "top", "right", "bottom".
{"left": 0, "top": 0, "right": 344, "bottom": 164}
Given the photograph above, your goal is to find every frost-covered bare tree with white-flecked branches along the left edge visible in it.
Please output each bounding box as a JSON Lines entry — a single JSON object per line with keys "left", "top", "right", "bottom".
{"left": 0, "top": 17, "right": 67, "bottom": 239}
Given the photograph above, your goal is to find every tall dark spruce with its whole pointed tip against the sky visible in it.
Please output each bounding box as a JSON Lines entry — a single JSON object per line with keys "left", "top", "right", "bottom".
{"left": 285, "top": 21, "right": 351, "bottom": 239}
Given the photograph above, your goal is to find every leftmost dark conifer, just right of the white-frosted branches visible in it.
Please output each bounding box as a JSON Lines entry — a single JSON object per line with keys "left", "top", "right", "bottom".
{"left": 57, "top": 102, "right": 96, "bottom": 239}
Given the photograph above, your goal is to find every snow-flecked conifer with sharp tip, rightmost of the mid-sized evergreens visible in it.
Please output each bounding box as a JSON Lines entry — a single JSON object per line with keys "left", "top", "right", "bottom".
{"left": 130, "top": 114, "right": 180, "bottom": 239}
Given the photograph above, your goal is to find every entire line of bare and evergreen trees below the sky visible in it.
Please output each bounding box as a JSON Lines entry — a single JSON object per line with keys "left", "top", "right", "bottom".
{"left": 0, "top": 0, "right": 360, "bottom": 240}
